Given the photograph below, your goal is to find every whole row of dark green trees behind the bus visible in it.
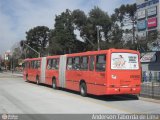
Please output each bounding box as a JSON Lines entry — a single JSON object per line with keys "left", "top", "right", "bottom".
{"left": 17, "top": 4, "right": 159, "bottom": 57}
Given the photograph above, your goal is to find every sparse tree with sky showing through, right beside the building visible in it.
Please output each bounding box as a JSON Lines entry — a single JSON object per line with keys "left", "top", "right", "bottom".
{"left": 111, "top": 4, "right": 136, "bottom": 47}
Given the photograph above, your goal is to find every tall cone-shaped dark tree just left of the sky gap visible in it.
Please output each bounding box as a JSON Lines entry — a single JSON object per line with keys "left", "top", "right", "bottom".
{"left": 49, "top": 9, "right": 80, "bottom": 54}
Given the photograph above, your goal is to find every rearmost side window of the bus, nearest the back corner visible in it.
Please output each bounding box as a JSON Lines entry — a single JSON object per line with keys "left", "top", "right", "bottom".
{"left": 96, "top": 55, "right": 106, "bottom": 71}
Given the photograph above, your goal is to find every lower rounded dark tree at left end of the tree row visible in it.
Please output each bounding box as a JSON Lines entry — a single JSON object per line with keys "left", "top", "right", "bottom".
{"left": 26, "top": 26, "right": 50, "bottom": 57}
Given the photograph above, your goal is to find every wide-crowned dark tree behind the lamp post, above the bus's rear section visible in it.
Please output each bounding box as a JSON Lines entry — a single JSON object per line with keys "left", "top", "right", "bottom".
{"left": 72, "top": 7, "right": 111, "bottom": 50}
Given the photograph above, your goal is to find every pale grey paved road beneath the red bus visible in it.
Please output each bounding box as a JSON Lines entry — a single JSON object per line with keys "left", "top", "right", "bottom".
{"left": 0, "top": 73, "right": 160, "bottom": 114}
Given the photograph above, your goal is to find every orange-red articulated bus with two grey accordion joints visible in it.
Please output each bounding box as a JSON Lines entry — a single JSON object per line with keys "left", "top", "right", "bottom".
{"left": 24, "top": 49, "right": 141, "bottom": 96}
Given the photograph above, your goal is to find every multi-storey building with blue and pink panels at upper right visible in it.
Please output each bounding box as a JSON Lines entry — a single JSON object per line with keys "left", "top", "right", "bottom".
{"left": 136, "top": 0, "right": 160, "bottom": 39}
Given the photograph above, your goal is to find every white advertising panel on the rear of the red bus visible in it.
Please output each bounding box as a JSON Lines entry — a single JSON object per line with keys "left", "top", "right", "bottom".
{"left": 111, "top": 53, "right": 139, "bottom": 70}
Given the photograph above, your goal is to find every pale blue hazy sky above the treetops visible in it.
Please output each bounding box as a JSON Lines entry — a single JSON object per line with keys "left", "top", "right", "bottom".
{"left": 0, "top": 0, "right": 135, "bottom": 54}
